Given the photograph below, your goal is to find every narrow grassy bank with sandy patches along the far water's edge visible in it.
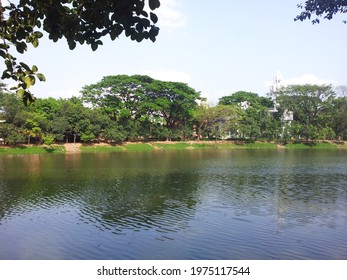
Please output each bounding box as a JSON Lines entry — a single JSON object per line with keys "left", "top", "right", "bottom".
{"left": 0, "top": 141, "right": 347, "bottom": 156}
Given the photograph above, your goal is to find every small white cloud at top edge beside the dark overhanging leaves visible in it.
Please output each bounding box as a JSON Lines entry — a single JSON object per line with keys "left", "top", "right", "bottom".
{"left": 155, "top": 0, "right": 186, "bottom": 30}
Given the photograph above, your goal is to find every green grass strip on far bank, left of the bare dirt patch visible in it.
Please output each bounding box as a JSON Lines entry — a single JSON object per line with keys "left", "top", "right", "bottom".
{"left": 0, "top": 146, "right": 65, "bottom": 155}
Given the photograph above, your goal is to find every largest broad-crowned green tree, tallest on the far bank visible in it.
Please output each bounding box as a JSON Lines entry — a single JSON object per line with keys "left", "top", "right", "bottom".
{"left": 81, "top": 75, "right": 200, "bottom": 139}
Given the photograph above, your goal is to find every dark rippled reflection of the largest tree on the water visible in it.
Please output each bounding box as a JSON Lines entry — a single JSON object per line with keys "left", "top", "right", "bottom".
{"left": 80, "top": 173, "right": 199, "bottom": 234}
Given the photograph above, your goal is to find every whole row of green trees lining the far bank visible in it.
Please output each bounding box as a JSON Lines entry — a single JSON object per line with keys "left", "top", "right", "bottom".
{"left": 0, "top": 75, "right": 347, "bottom": 145}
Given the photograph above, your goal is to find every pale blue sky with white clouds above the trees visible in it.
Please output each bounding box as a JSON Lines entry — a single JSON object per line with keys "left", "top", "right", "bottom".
{"left": 0, "top": 0, "right": 347, "bottom": 104}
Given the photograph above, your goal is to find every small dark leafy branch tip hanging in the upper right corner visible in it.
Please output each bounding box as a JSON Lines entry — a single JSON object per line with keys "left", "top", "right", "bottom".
{"left": 294, "top": 0, "right": 347, "bottom": 24}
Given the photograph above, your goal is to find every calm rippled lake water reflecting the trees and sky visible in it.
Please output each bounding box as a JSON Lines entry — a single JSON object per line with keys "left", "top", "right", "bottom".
{"left": 0, "top": 150, "right": 347, "bottom": 259}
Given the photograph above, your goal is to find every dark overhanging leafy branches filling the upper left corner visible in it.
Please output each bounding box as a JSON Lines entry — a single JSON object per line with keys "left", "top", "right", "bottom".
{"left": 0, "top": 0, "right": 160, "bottom": 105}
